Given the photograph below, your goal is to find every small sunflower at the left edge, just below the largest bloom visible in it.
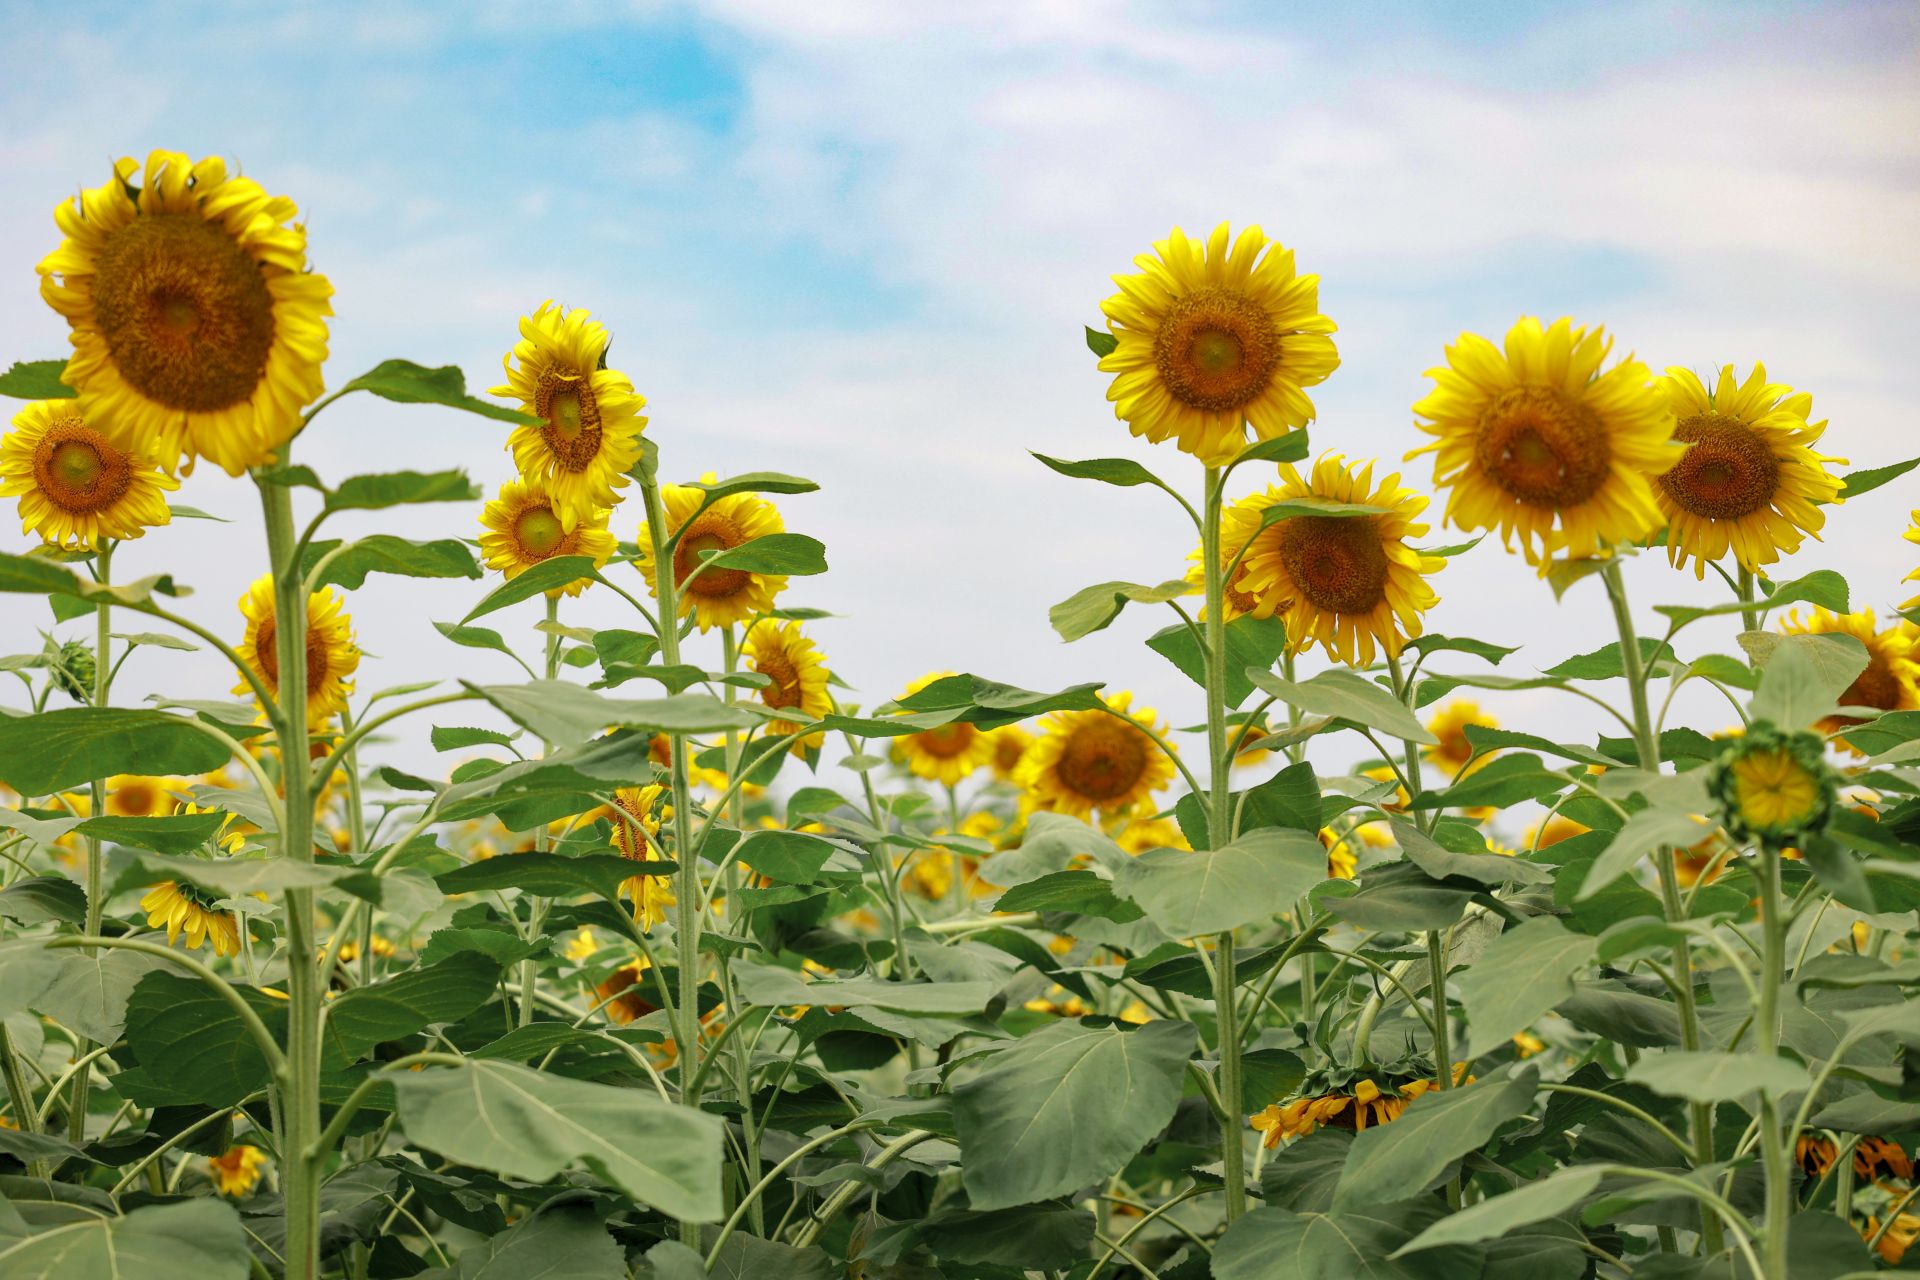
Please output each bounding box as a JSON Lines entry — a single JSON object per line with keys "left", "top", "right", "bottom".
{"left": 0, "top": 399, "right": 180, "bottom": 551}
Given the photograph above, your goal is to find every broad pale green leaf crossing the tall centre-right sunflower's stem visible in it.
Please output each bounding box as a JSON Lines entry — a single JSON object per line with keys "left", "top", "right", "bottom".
{"left": 1114, "top": 827, "right": 1327, "bottom": 938}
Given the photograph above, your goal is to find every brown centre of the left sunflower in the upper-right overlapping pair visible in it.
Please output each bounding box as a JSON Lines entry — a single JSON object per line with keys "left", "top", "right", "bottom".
{"left": 1475, "top": 386, "right": 1613, "bottom": 509}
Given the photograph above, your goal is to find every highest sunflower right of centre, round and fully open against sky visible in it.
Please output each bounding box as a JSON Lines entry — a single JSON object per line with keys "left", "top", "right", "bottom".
{"left": 1100, "top": 223, "right": 1340, "bottom": 466}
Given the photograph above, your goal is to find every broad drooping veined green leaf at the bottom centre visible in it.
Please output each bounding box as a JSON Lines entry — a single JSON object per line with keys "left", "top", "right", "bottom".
{"left": 954, "top": 1021, "right": 1196, "bottom": 1211}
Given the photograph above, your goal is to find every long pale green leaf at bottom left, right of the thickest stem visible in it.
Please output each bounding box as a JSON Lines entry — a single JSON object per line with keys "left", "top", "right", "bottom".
{"left": 392, "top": 1061, "right": 724, "bottom": 1222}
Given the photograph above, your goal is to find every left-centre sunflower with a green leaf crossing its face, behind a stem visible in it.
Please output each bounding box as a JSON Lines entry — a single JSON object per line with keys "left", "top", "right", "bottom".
{"left": 639, "top": 472, "right": 787, "bottom": 631}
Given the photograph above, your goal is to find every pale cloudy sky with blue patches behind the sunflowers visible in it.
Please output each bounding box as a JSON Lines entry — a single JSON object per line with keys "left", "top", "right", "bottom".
{"left": 0, "top": 0, "right": 1920, "bottom": 783}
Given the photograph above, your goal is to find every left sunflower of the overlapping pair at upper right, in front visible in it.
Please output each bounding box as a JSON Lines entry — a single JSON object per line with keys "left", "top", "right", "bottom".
{"left": 1407, "top": 317, "right": 1680, "bottom": 560}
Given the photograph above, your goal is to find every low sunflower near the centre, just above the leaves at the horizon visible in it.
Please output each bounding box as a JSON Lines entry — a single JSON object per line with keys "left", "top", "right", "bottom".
{"left": 1020, "top": 693, "right": 1173, "bottom": 818}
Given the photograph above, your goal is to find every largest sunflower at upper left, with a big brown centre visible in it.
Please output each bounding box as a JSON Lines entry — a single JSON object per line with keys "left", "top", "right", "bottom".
{"left": 38, "top": 152, "right": 334, "bottom": 476}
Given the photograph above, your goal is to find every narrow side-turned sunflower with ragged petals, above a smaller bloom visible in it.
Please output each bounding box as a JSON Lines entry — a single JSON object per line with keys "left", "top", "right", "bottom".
{"left": 490, "top": 301, "right": 647, "bottom": 532}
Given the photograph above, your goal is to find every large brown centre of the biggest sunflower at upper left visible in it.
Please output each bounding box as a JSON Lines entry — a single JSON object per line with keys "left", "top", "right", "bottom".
{"left": 94, "top": 213, "right": 273, "bottom": 413}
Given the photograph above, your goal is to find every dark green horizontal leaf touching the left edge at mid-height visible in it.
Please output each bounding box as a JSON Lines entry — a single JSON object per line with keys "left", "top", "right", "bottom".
{"left": 0, "top": 706, "right": 228, "bottom": 796}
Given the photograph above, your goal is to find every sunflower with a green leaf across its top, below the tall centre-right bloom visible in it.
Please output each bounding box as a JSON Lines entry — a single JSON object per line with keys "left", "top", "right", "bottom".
{"left": 1236, "top": 453, "right": 1446, "bottom": 666}
